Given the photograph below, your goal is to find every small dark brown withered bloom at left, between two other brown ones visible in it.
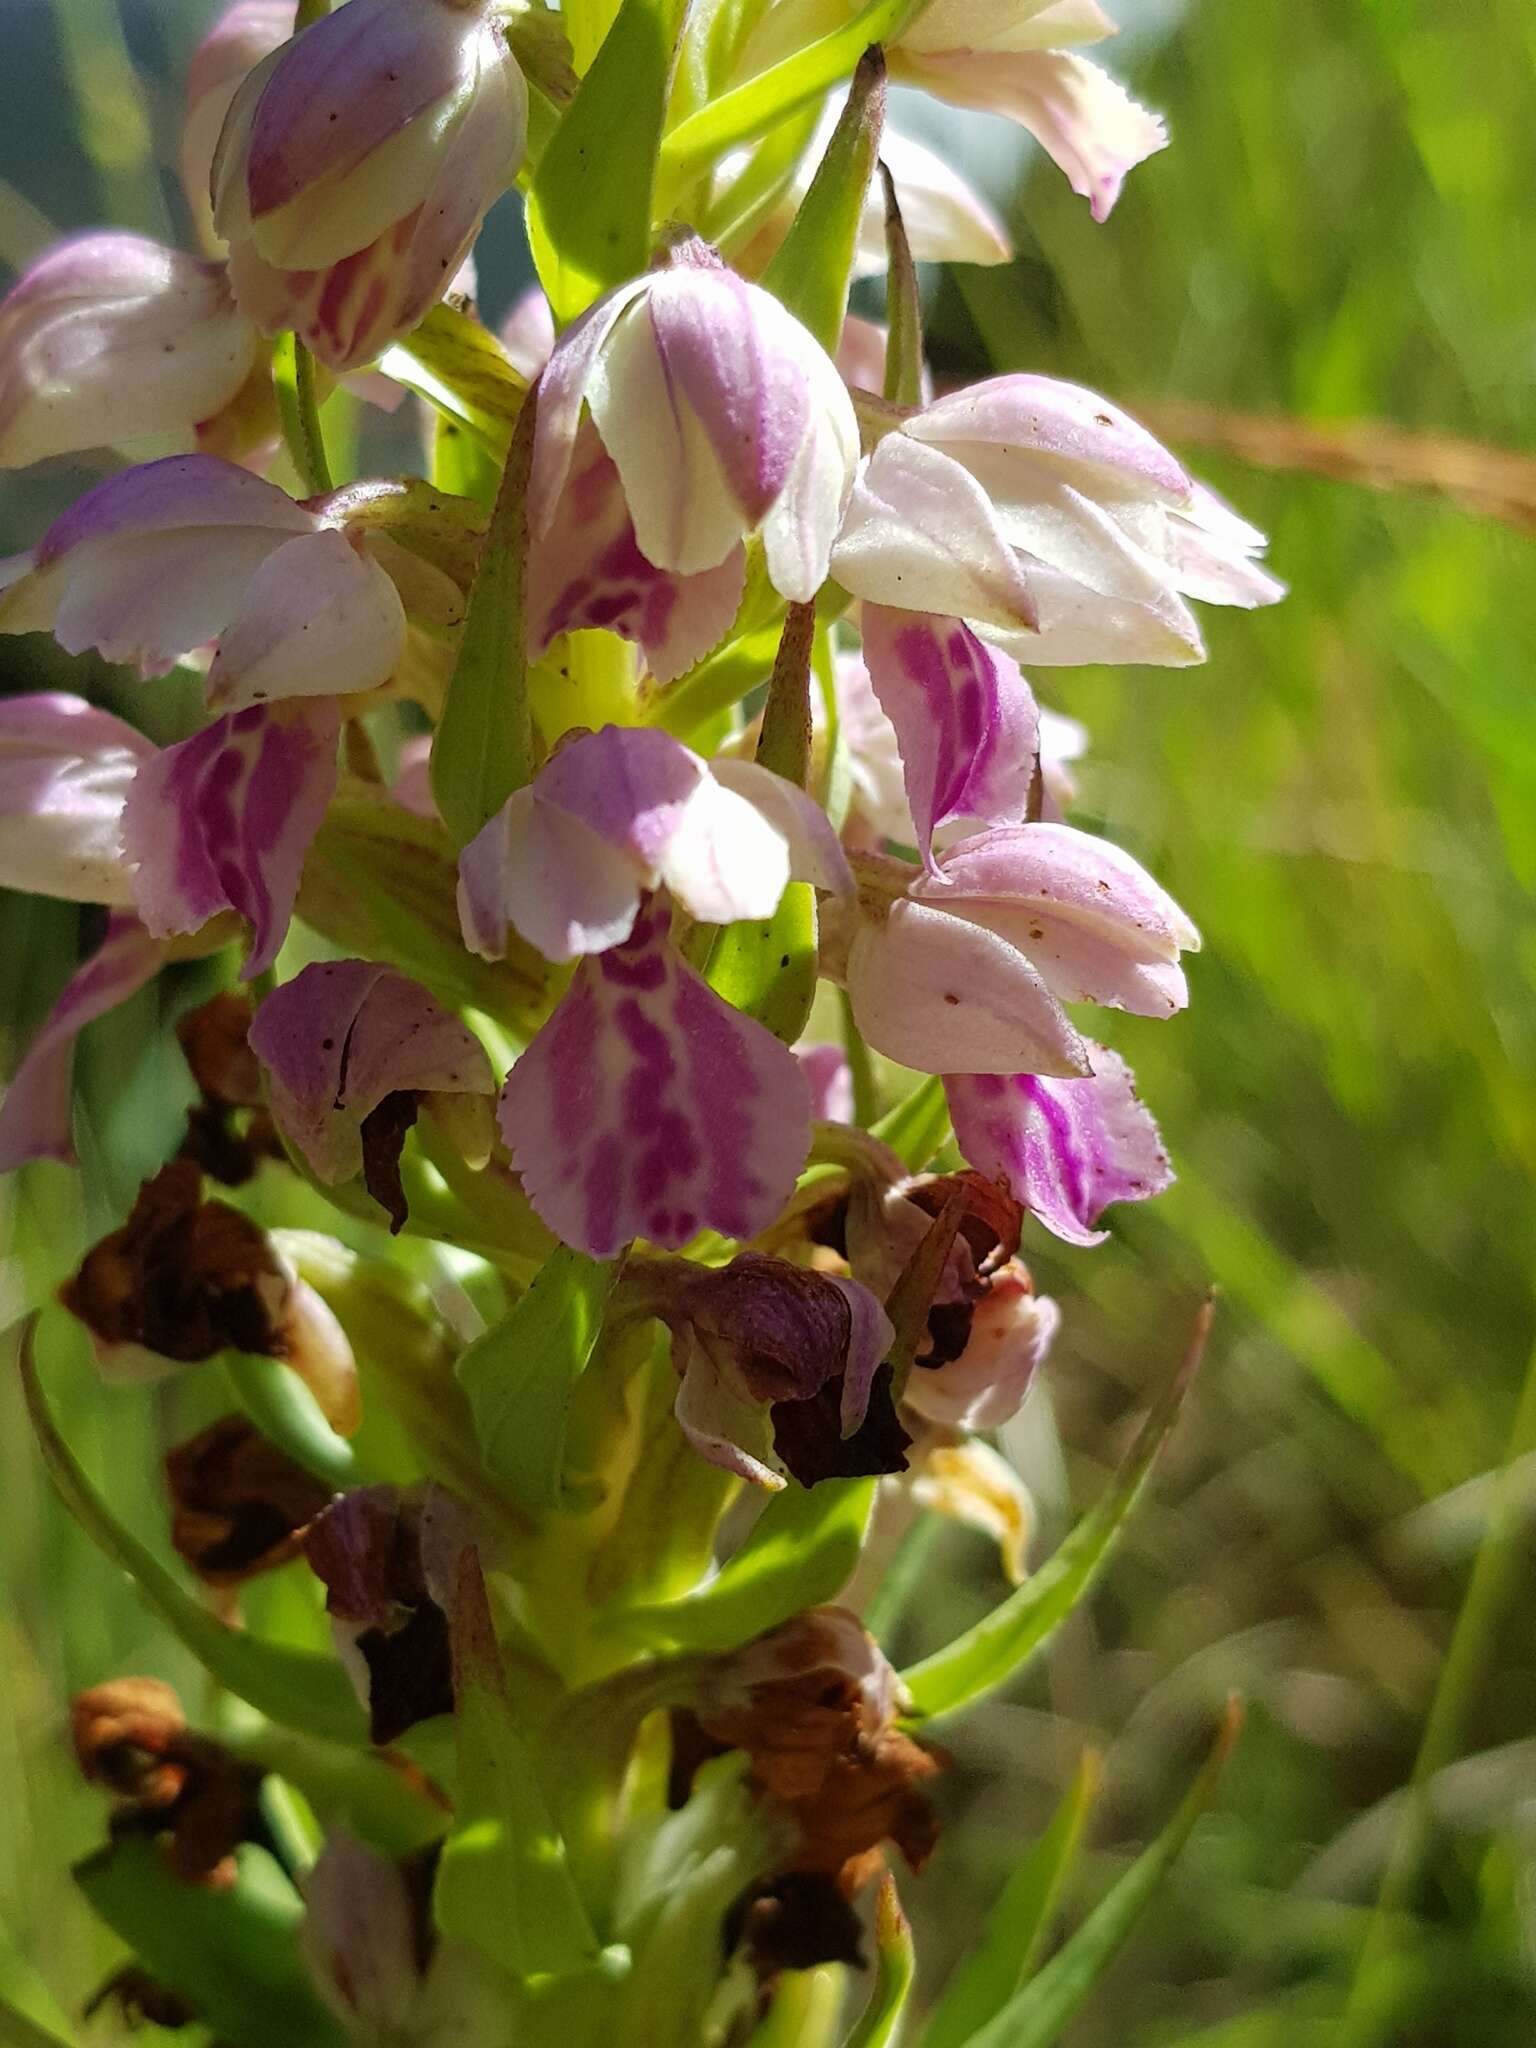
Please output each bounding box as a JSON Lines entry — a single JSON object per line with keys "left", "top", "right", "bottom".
{"left": 166, "top": 1415, "right": 332, "bottom": 1585}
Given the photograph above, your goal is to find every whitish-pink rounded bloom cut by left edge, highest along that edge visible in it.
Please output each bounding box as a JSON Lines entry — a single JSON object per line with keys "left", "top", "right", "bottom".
{"left": 0, "top": 233, "right": 258, "bottom": 469}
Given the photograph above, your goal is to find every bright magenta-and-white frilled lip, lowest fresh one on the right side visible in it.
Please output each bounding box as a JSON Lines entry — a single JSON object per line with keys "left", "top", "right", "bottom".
{"left": 944, "top": 1044, "right": 1174, "bottom": 1245}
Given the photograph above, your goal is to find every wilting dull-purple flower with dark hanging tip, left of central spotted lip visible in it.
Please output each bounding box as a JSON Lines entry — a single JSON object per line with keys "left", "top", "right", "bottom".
{"left": 250, "top": 961, "right": 496, "bottom": 1229}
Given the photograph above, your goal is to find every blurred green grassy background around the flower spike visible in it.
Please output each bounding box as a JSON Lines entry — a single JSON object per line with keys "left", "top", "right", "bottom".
{"left": 0, "top": 0, "right": 1536, "bottom": 2048}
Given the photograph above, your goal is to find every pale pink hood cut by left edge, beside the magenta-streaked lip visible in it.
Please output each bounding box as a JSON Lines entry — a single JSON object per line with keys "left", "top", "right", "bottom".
{"left": 0, "top": 692, "right": 156, "bottom": 909}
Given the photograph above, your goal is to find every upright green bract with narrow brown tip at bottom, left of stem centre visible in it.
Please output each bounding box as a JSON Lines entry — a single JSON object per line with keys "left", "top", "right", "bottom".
{"left": 432, "top": 1548, "right": 598, "bottom": 1978}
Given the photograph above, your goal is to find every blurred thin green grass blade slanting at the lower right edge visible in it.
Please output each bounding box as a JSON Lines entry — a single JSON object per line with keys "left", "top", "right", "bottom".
{"left": 1341, "top": 1350, "right": 1536, "bottom": 2048}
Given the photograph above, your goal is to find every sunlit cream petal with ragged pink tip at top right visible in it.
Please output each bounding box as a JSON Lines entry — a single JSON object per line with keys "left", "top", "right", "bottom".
{"left": 893, "top": 49, "right": 1167, "bottom": 221}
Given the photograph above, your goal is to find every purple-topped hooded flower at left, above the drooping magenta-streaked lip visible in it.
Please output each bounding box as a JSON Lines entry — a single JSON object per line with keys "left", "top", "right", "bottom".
{"left": 0, "top": 455, "right": 406, "bottom": 711}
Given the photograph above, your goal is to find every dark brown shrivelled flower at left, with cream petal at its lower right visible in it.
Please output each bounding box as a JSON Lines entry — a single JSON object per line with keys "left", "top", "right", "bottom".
{"left": 59, "top": 1159, "right": 289, "bottom": 1364}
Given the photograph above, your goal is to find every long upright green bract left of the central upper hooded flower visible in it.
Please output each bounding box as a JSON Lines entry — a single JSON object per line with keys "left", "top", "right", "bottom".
{"left": 432, "top": 393, "right": 539, "bottom": 846}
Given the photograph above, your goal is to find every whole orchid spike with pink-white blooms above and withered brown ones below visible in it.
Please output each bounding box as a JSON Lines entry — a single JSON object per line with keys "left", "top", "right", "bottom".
{"left": 0, "top": 0, "right": 1280, "bottom": 2048}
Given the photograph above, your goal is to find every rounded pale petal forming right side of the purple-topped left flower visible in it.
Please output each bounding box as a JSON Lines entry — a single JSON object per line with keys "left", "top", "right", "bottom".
{"left": 207, "top": 528, "right": 406, "bottom": 711}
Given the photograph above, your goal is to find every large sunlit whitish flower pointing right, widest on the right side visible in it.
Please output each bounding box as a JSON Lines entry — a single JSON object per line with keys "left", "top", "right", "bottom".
{"left": 831, "top": 375, "right": 1284, "bottom": 666}
